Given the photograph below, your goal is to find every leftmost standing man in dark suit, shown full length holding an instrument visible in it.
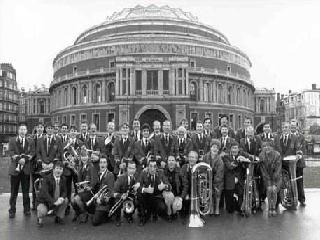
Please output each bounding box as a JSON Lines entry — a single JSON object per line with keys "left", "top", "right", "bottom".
{"left": 9, "top": 124, "right": 34, "bottom": 218}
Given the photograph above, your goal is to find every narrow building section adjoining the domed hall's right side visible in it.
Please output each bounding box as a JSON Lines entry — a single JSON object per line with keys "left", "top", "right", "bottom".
{"left": 254, "top": 88, "right": 278, "bottom": 133}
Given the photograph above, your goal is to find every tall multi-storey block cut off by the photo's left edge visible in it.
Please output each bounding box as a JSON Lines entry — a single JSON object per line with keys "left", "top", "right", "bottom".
{"left": 0, "top": 63, "right": 19, "bottom": 143}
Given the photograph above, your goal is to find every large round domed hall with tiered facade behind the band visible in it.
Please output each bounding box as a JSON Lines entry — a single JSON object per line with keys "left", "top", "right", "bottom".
{"left": 50, "top": 5, "right": 254, "bottom": 131}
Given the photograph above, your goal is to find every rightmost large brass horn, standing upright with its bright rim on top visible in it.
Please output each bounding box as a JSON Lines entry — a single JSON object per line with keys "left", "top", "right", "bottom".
{"left": 280, "top": 153, "right": 302, "bottom": 209}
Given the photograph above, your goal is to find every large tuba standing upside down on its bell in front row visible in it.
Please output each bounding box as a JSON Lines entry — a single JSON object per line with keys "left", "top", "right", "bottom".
{"left": 189, "top": 162, "right": 212, "bottom": 227}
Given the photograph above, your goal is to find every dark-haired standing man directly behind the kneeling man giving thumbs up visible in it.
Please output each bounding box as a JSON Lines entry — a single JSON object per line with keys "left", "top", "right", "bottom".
{"left": 133, "top": 123, "right": 155, "bottom": 173}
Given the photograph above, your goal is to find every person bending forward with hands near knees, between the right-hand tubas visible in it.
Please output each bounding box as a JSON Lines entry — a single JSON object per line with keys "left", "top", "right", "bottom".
{"left": 259, "top": 142, "right": 281, "bottom": 216}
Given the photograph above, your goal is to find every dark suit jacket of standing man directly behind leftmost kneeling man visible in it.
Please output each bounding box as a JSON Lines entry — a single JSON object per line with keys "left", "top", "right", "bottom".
{"left": 37, "top": 136, "right": 62, "bottom": 164}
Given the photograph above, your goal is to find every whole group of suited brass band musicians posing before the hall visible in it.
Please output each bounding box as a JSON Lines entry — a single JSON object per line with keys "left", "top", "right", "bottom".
{"left": 9, "top": 116, "right": 305, "bottom": 227}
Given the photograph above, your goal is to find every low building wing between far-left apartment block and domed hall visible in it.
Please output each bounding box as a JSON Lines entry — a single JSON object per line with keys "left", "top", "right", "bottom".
{"left": 19, "top": 86, "right": 51, "bottom": 133}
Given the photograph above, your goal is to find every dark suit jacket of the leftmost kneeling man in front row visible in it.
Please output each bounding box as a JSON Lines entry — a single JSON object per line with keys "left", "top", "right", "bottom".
{"left": 38, "top": 173, "right": 67, "bottom": 208}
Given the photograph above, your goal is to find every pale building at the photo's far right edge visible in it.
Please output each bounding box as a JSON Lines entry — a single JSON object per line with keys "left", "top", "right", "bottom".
{"left": 282, "top": 84, "right": 320, "bottom": 133}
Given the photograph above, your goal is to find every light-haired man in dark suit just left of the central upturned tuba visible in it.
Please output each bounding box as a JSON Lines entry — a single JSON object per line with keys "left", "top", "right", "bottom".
{"left": 180, "top": 151, "right": 198, "bottom": 221}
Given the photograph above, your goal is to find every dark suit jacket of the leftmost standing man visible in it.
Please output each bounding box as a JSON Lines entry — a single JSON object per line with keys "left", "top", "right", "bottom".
{"left": 9, "top": 137, "right": 35, "bottom": 176}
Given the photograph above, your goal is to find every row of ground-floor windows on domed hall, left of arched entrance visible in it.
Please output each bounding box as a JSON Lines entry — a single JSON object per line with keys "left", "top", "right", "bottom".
{"left": 53, "top": 112, "right": 115, "bottom": 131}
